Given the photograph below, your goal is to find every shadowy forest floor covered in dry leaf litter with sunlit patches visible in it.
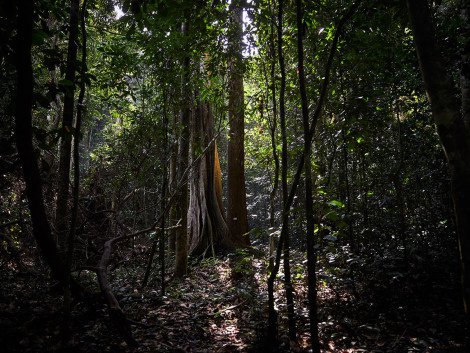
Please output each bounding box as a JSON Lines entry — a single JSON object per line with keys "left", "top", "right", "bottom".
{"left": 0, "top": 241, "right": 465, "bottom": 353}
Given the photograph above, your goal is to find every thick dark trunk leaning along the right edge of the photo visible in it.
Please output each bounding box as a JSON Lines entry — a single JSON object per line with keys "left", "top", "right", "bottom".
{"left": 408, "top": 0, "right": 470, "bottom": 334}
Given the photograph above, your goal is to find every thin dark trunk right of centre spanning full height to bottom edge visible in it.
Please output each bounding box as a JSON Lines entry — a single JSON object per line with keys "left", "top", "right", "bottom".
{"left": 296, "top": 0, "right": 320, "bottom": 353}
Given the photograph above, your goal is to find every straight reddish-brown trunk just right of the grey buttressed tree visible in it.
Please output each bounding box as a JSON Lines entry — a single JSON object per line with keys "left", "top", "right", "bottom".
{"left": 227, "top": 1, "right": 250, "bottom": 245}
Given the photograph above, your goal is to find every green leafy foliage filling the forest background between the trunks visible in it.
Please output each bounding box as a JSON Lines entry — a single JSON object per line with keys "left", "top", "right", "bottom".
{"left": 0, "top": 0, "right": 465, "bottom": 351}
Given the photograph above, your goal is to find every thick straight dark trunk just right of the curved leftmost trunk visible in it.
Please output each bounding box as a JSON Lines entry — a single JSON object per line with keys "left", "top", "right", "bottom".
{"left": 55, "top": 0, "right": 79, "bottom": 247}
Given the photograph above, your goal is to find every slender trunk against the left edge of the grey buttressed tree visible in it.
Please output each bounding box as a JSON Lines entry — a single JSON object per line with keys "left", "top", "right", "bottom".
{"left": 175, "top": 19, "right": 191, "bottom": 277}
